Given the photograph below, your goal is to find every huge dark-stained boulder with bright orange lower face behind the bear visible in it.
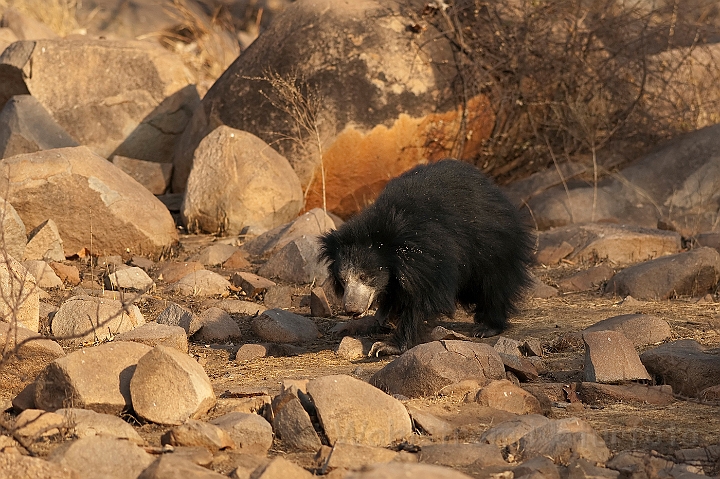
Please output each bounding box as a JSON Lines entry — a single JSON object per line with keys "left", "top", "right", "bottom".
{"left": 173, "top": 0, "right": 494, "bottom": 216}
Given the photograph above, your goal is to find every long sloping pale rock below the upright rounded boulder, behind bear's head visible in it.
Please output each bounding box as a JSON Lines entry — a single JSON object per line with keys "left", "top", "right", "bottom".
{"left": 242, "top": 208, "right": 335, "bottom": 258}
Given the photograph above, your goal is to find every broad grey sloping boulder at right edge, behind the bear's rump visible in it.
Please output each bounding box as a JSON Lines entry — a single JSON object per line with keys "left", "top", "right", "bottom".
{"left": 527, "top": 125, "right": 720, "bottom": 236}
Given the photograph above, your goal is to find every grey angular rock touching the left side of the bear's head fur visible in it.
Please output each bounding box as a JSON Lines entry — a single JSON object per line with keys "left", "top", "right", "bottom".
{"left": 258, "top": 236, "right": 328, "bottom": 284}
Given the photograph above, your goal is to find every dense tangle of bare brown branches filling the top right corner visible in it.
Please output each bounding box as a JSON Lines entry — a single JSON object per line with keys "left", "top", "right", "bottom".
{"left": 422, "top": 0, "right": 720, "bottom": 181}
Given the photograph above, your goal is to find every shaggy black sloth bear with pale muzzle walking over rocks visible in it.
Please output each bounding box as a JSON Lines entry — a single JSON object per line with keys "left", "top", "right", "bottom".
{"left": 320, "top": 159, "right": 534, "bottom": 356}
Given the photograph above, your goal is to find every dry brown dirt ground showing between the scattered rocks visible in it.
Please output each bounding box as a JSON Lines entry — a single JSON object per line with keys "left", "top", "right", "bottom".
{"left": 7, "top": 232, "right": 720, "bottom": 474}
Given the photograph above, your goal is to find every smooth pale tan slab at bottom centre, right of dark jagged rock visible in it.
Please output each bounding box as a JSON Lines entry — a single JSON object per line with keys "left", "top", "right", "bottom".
{"left": 307, "top": 375, "right": 412, "bottom": 447}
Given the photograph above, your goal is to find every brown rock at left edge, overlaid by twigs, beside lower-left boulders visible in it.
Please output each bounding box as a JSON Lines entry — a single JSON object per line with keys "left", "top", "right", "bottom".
{"left": 0, "top": 322, "right": 65, "bottom": 394}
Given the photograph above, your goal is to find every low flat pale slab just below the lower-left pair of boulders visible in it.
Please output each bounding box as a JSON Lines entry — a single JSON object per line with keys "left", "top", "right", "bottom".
{"left": 55, "top": 408, "right": 145, "bottom": 446}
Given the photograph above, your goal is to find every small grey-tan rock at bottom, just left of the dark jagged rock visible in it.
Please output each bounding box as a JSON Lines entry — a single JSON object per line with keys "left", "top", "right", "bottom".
{"left": 210, "top": 412, "right": 273, "bottom": 456}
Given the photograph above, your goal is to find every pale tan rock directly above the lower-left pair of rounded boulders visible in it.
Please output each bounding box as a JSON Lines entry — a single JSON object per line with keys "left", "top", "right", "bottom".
{"left": 51, "top": 295, "right": 145, "bottom": 345}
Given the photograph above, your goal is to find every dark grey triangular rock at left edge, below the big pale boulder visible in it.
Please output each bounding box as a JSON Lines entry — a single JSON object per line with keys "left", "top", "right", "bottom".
{"left": 0, "top": 95, "right": 78, "bottom": 158}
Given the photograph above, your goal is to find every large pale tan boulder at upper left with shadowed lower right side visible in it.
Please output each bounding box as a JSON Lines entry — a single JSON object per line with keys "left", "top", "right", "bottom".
{"left": 0, "top": 39, "right": 199, "bottom": 163}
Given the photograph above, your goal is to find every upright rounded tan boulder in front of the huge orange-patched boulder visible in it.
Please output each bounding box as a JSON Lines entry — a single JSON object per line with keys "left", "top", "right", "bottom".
{"left": 182, "top": 126, "right": 303, "bottom": 235}
